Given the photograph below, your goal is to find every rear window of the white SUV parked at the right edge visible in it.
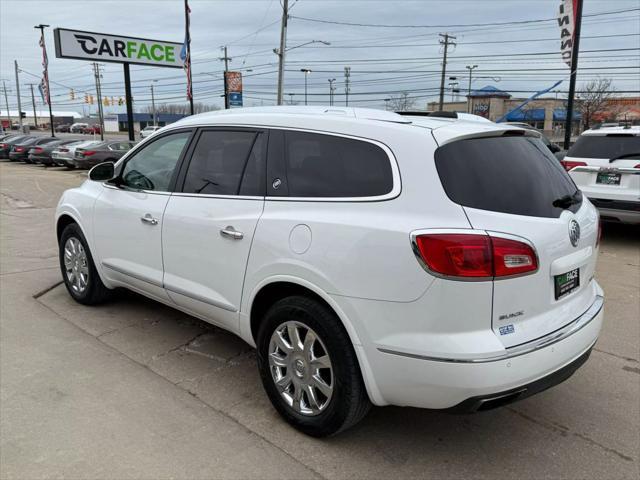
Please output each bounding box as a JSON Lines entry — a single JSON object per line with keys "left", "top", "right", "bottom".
{"left": 567, "top": 133, "right": 640, "bottom": 160}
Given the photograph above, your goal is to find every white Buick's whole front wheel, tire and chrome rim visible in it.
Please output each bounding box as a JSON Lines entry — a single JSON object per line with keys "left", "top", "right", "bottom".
{"left": 59, "top": 223, "right": 111, "bottom": 305}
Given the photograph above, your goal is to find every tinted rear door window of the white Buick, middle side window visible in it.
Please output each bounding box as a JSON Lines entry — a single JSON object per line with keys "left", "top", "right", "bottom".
{"left": 182, "top": 130, "right": 264, "bottom": 195}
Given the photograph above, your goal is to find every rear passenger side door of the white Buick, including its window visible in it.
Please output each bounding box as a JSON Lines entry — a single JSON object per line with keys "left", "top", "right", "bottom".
{"left": 162, "top": 128, "right": 267, "bottom": 331}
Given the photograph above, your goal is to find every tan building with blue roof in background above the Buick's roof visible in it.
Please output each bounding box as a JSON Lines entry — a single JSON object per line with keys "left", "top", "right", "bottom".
{"left": 427, "top": 85, "right": 581, "bottom": 135}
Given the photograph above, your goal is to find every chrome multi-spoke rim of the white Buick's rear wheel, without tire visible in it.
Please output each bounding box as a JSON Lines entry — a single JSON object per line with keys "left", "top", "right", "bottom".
{"left": 269, "top": 321, "right": 334, "bottom": 416}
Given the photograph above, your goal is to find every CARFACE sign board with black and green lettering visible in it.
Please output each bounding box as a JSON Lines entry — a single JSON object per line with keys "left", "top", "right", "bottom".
{"left": 54, "top": 28, "right": 182, "bottom": 68}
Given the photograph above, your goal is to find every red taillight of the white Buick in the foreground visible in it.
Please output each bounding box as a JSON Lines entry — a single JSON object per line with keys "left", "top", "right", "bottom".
{"left": 414, "top": 233, "right": 538, "bottom": 278}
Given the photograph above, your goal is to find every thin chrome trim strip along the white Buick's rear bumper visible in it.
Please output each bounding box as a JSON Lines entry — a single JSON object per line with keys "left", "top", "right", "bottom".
{"left": 378, "top": 295, "right": 604, "bottom": 363}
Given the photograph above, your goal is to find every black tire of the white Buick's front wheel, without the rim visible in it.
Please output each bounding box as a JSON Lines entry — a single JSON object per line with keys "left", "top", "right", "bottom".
{"left": 58, "top": 223, "right": 112, "bottom": 305}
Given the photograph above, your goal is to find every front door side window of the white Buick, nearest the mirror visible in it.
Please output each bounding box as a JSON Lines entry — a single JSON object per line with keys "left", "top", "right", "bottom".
{"left": 121, "top": 132, "right": 191, "bottom": 192}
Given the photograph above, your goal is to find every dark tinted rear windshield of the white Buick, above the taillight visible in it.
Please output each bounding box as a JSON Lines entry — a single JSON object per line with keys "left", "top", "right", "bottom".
{"left": 435, "top": 136, "right": 581, "bottom": 218}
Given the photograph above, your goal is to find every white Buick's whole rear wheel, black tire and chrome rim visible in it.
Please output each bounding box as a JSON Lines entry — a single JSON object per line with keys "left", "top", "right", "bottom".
{"left": 258, "top": 296, "right": 371, "bottom": 437}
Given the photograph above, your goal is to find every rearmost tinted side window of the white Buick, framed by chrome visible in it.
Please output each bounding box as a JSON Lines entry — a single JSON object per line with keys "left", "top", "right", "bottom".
{"left": 285, "top": 131, "right": 393, "bottom": 197}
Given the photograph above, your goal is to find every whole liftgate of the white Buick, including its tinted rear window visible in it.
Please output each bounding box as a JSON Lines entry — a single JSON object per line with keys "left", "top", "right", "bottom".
{"left": 436, "top": 136, "right": 598, "bottom": 347}
